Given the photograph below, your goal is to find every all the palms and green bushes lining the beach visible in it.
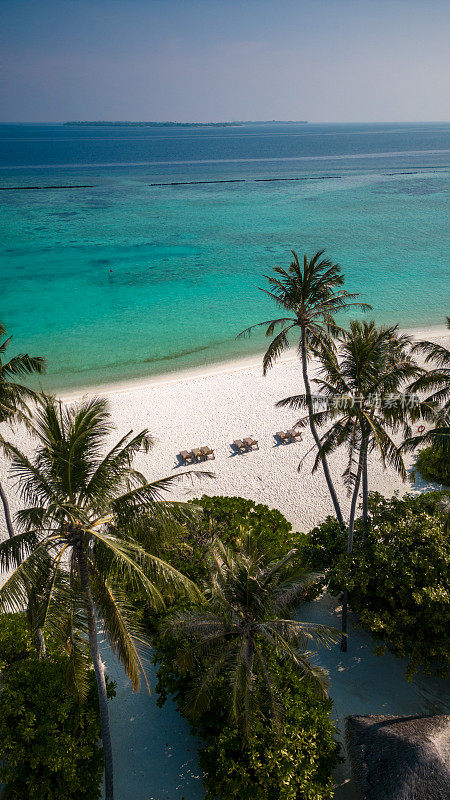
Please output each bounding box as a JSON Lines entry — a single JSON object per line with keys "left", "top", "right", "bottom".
{"left": 0, "top": 268, "right": 450, "bottom": 800}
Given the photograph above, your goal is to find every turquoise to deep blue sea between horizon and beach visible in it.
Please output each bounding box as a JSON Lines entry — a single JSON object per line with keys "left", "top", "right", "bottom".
{"left": 0, "top": 123, "right": 450, "bottom": 388}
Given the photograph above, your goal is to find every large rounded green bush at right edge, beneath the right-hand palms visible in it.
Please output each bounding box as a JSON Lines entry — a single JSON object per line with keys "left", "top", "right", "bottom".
{"left": 308, "top": 492, "right": 450, "bottom": 677}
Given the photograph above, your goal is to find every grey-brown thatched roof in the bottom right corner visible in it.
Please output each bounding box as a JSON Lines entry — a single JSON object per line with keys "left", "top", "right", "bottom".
{"left": 347, "top": 715, "right": 450, "bottom": 800}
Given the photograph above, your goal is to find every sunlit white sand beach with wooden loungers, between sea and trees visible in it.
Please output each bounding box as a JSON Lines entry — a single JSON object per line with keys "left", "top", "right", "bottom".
{"left": 0, "top": 328, "right": 444, "bottom": 535}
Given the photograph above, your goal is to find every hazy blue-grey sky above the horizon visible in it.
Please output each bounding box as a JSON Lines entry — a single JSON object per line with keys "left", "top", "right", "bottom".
{"left": 0, "top": 0, "right": 450, "bottom": 122}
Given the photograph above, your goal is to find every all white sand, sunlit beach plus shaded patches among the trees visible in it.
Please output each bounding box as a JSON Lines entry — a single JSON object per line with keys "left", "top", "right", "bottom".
{"left": 0, "top": 328, "right": 450, "bottom": 800}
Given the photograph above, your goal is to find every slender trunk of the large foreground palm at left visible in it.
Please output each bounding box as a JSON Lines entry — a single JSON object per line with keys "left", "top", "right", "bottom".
{"left": 77, "top": 546, "right": 114, "bottom": 800}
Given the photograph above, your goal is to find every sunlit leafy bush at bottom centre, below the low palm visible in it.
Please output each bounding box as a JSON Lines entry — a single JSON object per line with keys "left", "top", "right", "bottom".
{"left": 200, "top": 665, "right": 341, "bottom": 800}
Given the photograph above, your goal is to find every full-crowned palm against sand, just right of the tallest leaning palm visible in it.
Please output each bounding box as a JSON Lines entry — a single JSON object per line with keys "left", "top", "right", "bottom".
{"left": 277, "top": 321, "right": 421, "bottom": 650}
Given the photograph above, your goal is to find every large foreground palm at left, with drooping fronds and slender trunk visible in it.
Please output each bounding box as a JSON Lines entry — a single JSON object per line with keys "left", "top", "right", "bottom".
{"left": 0, "top": 397, "right": 199, "bottom": 800}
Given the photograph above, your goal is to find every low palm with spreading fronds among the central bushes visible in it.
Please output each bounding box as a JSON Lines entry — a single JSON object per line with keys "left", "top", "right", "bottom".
{"left": 165, "top": 537, "right": 336, "bottom": 735}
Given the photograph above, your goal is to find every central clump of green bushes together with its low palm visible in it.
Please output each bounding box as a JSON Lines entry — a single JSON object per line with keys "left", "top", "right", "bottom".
{"left": 154, "top": 512, "right": 340, "bottom": 800}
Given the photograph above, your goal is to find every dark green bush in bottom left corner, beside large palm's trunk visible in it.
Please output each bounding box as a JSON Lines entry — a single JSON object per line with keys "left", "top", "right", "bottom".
{"left": 0, "top": 614, "right": 114, "bottom": 800}
